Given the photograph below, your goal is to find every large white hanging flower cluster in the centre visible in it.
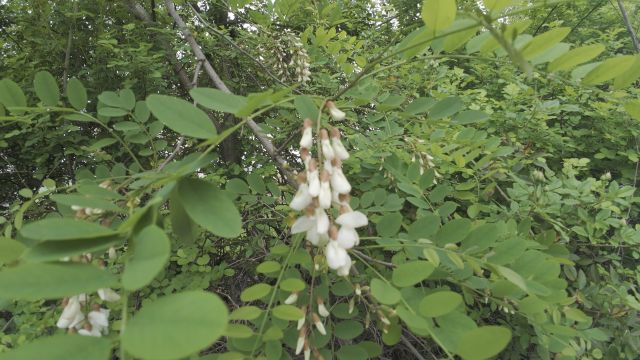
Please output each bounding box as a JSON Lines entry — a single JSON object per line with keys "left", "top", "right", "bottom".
{"left": 290, "top": 102, "right": 368, "bottom": 276}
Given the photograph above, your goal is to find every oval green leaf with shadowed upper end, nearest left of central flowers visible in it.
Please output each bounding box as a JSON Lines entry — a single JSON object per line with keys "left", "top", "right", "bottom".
{"left": 177, "top": 179, "right": 242, "bottom": 238}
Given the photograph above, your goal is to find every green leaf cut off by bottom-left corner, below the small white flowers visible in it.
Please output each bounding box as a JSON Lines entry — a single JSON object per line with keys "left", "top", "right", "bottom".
{"left": 0, "top": 334, "right": 112, "bottom": 360}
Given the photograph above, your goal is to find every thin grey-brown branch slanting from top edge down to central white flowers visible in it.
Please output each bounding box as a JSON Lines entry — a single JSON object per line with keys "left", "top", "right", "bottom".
{"left": 165, "top": 0, "right": 297, "bottom": 187}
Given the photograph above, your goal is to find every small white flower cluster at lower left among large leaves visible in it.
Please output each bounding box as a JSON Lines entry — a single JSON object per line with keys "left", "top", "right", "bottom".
{"left": 56, "top": 288, "right": 120, "bottom": 337}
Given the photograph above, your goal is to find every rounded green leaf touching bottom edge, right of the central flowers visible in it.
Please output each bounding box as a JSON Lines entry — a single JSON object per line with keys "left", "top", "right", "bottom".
{"left": 455, "top": 326, "right": 511, "bottom": 360}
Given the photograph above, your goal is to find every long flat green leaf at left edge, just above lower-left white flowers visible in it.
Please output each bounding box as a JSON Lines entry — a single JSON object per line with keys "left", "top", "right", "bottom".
{"left": 0, "top": 263, "right": 116, "bottom": 300}
